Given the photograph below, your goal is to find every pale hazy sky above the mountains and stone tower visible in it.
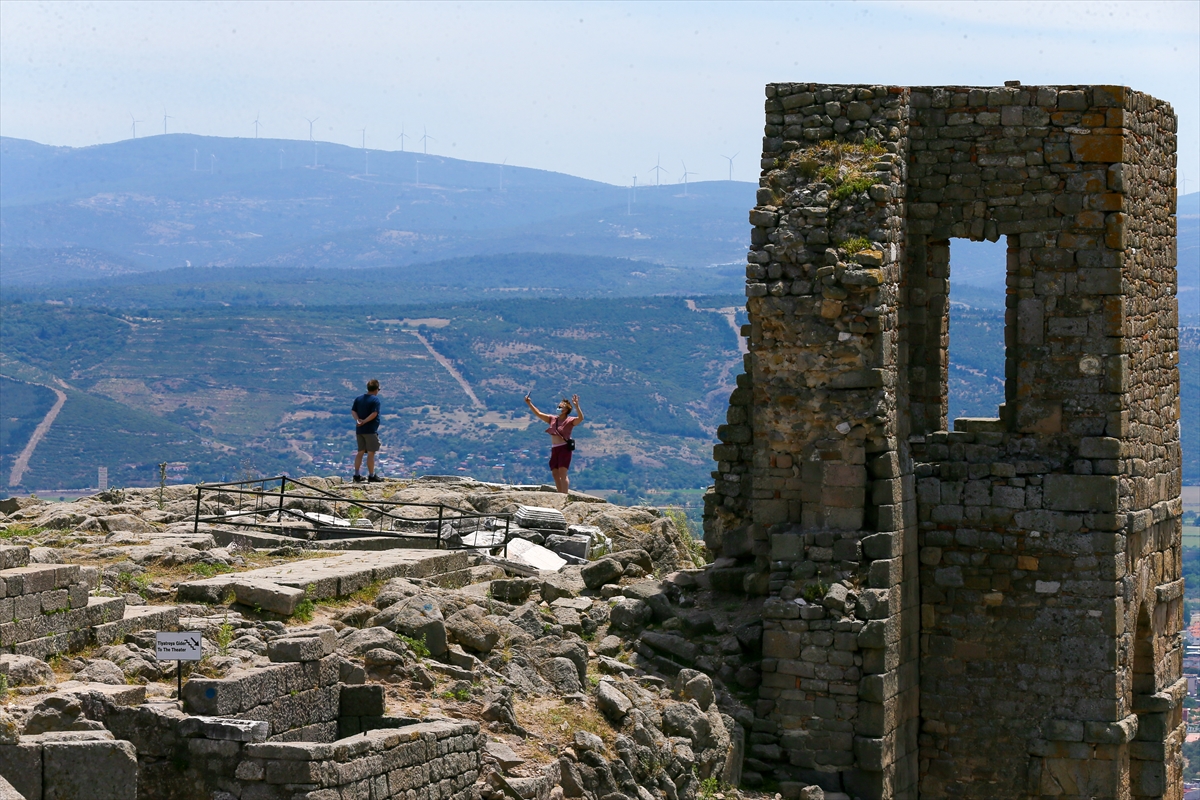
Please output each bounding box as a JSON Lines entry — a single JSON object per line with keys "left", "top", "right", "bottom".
{"left": 0, "top": 0, "right": 1200, "bottom": 192}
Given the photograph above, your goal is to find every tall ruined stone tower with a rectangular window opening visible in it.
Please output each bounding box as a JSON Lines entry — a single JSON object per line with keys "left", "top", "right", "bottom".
{"left": 704, "top": 84, "right": 1184, "bottom": 798}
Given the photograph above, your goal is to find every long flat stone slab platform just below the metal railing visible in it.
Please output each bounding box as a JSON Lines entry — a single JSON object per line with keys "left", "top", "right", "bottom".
{"left": 176, "top": 549, "right": 475, "bottom": 602}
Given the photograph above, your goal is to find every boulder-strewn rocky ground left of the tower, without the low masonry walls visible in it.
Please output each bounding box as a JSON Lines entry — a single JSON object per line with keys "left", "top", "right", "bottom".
{"left": 0, "top": 479, "right": 838, "bottom": 800}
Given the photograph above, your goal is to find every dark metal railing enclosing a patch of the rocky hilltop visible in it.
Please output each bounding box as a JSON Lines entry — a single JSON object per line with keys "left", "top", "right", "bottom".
{"left": 192, "top": 475, "right": 512, "bottom": 557}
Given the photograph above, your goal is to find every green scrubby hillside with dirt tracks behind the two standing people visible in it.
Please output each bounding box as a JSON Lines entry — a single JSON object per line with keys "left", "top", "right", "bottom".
{"left": 0, "top": 295, "right": 1200, "bottom": 498}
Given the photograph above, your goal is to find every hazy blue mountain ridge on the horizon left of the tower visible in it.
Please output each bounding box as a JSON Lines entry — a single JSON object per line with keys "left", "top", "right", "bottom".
{"left": 0, "top": 133, "right": 755, "bottom": 284}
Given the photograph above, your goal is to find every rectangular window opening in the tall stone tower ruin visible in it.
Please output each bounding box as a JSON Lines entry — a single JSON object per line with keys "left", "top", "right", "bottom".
{"left": 947, "top": 239, "right": 1008, "bottom": 427}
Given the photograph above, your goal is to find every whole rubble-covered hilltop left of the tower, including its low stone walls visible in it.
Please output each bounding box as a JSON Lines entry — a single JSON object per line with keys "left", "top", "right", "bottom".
{"left": 0, "top": 479, "right": 821, "bottom": 800}
